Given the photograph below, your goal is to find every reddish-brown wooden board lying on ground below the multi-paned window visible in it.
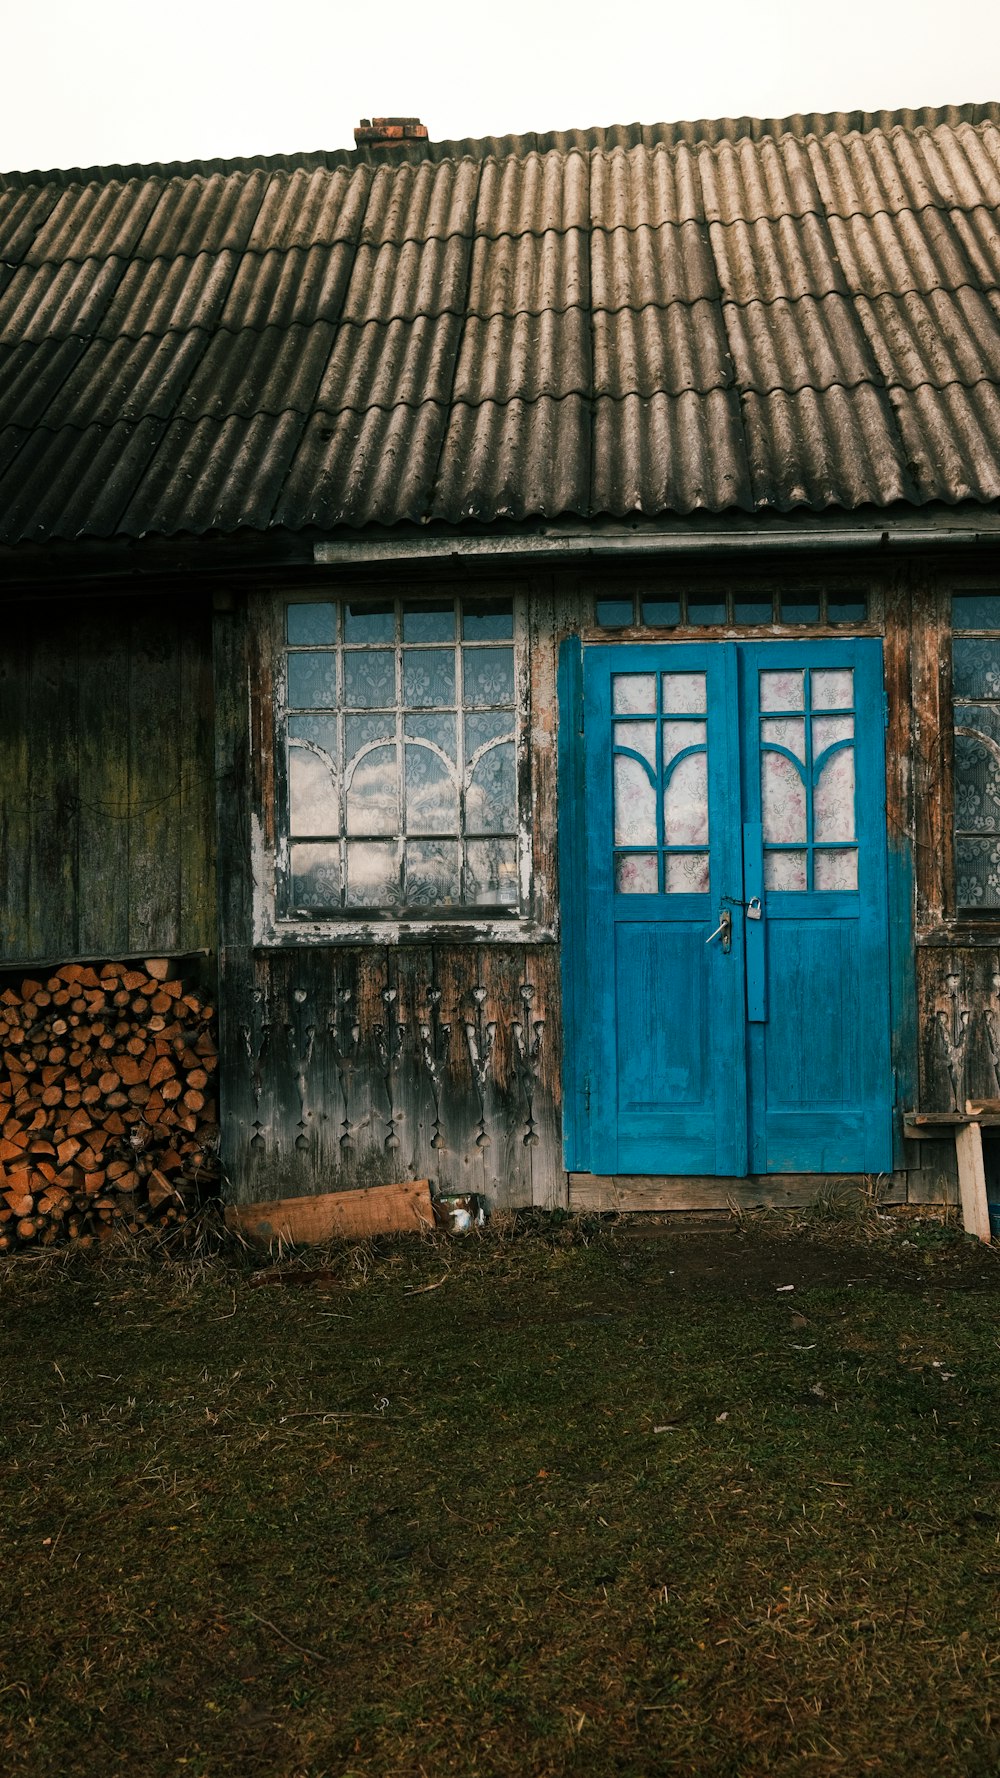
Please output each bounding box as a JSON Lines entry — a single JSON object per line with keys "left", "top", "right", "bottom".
{"left": 226, "top": 1179, "right": 434, "bottom": 1246}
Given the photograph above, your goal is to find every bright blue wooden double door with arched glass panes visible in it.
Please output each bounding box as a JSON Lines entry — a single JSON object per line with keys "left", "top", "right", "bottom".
{"left": 562, "top": 638, "right": 891, "bottom": 1175}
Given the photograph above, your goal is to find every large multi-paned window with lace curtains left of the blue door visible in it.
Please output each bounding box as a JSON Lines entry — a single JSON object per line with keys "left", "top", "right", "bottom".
{"left": 278, "top": 597, "right": 520, "bottom": 917}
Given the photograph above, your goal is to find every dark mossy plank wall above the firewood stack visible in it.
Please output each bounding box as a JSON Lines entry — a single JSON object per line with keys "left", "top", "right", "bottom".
{"left": 0, "top": 590, "right": 215, "bottom": 964}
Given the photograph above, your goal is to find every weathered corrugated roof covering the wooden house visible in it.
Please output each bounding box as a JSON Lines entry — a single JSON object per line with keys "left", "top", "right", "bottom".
{"left": 0, "top": 105, "right": 1000, "bottom": 542}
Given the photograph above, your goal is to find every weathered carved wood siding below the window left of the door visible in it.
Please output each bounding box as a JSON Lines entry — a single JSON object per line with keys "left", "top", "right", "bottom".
{"left": 222, "top": 944, "right": 562, "bottom": 1205}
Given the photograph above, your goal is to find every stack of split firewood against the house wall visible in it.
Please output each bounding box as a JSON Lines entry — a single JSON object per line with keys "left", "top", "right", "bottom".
{"left": 0, "top": 958, "right": 219, "bottom": 1252}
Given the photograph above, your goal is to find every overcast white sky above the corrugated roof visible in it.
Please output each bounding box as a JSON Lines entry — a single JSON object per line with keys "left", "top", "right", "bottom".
{"left": 0, "top": 0, "right": 1000, "bottom": 171}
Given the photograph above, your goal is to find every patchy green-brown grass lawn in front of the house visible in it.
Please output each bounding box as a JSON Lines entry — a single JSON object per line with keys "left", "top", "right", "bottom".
{"left": 0, "top": 1220, "right": 1000, "bottom": 1778}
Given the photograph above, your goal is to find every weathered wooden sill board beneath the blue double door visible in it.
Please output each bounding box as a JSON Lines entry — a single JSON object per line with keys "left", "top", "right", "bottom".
{"left": 569, "top": 1173, "right": 902, "bottom": 1211}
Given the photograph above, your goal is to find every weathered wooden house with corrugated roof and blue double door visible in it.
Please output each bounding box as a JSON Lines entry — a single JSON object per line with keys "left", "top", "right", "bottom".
{"left": 0, "top": 105, "right": 1000, "bottom": 1207}
